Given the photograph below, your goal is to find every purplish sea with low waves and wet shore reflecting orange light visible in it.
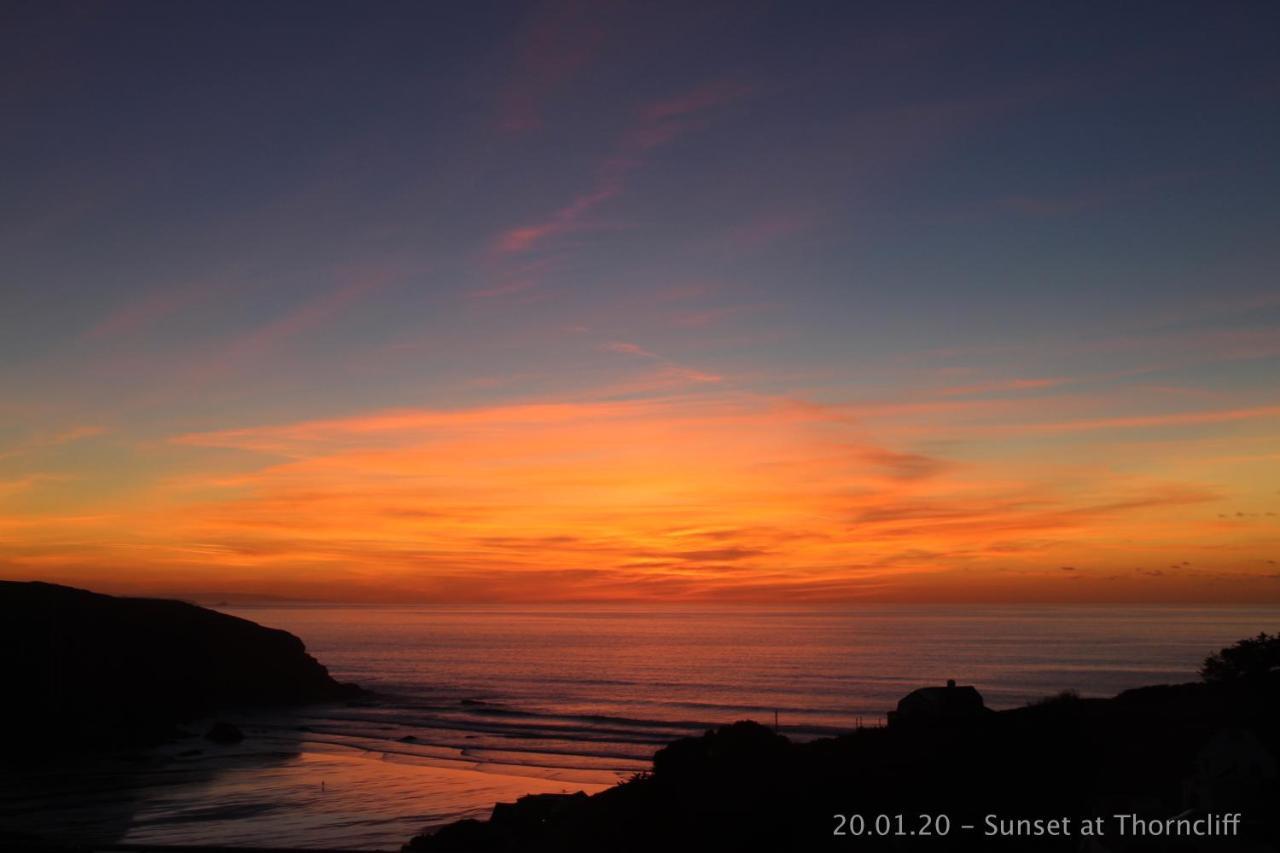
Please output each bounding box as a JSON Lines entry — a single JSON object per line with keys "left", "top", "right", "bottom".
{"left": 0, "top": 606, "right": 1280, "bottom": 849}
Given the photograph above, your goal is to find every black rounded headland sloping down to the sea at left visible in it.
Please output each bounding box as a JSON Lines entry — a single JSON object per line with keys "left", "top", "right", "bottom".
{"left": 0, "top": 581, "right": 361, "bottom": 757}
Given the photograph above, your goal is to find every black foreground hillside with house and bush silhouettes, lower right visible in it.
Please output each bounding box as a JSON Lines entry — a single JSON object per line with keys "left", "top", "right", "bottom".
{"left": 404, "top": 671, "right": 1280, "bottom": 853}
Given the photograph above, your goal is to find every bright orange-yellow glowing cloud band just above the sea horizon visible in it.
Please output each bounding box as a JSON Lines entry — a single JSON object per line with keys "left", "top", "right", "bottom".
{"left": 0, "top": 381, "right": 1275, "bottom": 602}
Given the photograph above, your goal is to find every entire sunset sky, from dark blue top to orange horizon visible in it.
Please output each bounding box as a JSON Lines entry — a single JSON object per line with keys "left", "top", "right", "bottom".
{"left": 0, "top": 1, "right": 1280, "bottom": 605}
